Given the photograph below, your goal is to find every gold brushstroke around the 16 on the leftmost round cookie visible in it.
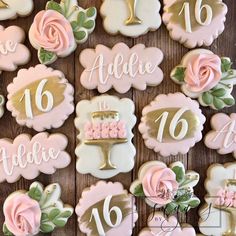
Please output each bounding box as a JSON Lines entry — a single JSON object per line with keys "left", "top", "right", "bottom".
{"left": 10, "top": 76, "right": 66, "bottom": 119}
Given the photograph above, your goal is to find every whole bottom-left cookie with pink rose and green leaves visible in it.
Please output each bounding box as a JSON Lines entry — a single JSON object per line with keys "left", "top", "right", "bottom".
{"left": 3, "top": 182, "right": 74, "bottom": 236}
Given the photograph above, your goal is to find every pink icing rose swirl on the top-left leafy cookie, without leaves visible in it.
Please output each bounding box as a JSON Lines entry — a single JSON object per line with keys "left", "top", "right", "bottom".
{"left": 30, "top": 10, "right": 75, "bottom": 55}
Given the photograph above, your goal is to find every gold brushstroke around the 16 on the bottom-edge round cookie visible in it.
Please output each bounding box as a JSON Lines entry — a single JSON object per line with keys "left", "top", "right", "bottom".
{"left": 80, "top": 194, "right": 132, "bottom": 236}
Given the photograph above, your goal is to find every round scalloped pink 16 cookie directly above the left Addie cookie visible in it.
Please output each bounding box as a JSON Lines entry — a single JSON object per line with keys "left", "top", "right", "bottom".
{"left": 7, "top": 65, "right": 74, "bottom": 131}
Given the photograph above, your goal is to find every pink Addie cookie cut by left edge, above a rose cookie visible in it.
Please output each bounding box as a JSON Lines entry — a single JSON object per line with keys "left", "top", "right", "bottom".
{"left": 0, "top": 133, "right": 71, "bottom": 183}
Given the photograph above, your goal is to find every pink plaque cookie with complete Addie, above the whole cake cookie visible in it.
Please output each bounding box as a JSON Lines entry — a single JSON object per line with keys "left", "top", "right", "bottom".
{"left": 80, "top": 43, "right": 163, "bottom": 93}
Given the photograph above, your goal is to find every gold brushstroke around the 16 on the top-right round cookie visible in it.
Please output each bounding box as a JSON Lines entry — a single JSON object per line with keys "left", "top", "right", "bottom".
{"left": 167, "top": 0, "right": 224, "bottom": 31}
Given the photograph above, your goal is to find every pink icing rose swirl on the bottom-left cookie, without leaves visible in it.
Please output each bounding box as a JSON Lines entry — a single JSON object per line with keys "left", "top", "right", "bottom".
{"left": 4, "top": 193, "right": 41, "bottom": 236}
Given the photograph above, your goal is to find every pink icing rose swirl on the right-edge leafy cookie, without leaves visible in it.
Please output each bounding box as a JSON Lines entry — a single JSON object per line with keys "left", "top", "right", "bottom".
{"left": 184, "top": 54, "right": 222, "bottom": 93}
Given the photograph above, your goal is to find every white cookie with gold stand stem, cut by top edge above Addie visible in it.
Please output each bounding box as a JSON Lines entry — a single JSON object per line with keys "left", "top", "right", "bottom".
{"left": 100, "top": 0, "right": 161, "bottom": 38}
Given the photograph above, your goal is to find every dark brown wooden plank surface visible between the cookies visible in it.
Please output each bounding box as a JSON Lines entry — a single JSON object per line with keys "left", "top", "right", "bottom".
{"left": 0, "top": 0, "right": 236, "bottom": 236}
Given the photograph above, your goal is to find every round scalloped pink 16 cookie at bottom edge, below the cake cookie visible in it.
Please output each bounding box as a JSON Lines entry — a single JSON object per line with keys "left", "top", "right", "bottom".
{"left": 75, "top": 181, "right": 138, "bottom": 236}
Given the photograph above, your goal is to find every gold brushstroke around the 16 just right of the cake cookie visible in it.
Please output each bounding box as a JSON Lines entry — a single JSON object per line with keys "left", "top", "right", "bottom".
{"left": 146, "top": 108, "right": 200, "bottom": 143}
